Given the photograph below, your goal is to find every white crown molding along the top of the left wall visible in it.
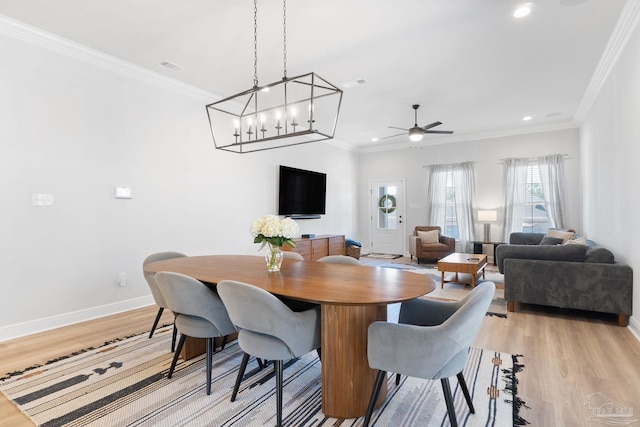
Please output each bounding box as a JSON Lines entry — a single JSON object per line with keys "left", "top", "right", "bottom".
{"left": 0, "top": 15, "right": 215, "bottom": 102}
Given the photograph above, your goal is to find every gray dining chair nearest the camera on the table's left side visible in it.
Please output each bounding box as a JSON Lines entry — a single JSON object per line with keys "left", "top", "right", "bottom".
{"left": 217, "top": 280, "right": 320, "bottom": 427}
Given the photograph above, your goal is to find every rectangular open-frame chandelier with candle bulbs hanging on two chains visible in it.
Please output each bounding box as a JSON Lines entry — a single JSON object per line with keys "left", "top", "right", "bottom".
{"left": 206, "top": 0, "right": 342, "bottom": 153}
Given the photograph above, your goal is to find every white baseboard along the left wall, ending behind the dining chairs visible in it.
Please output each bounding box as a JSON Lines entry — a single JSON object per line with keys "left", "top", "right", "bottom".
{"left": 0, "top": 295, "right": 155, "bottom": 342}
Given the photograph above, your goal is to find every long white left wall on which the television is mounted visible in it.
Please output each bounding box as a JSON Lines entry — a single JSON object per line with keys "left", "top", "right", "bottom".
{"left": 0, "top": 32, "right": 357, "bottom": 341}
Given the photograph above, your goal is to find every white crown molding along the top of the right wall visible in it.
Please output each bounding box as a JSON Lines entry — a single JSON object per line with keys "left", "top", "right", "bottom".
{"left": 573, "top": 0, "right": 640, "bottom": 124}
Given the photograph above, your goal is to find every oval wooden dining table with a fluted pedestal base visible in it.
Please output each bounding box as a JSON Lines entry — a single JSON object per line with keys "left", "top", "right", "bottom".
{"left": 144, "top": 255, "right": 435, "bottom": 418}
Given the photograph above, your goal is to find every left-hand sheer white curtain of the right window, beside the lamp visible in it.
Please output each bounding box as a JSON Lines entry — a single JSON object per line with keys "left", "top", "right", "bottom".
{"left": 502, "top": 159, "right": 529, "bottom": 242}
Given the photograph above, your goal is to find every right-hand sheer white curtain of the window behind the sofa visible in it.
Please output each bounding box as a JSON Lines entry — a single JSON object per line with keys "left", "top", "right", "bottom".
{"left": 538, "top": 154, "right": 567, "bottom": 228}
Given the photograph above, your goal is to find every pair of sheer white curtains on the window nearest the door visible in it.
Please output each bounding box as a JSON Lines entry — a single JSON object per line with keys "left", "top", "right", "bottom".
{"left": 427, "top": 162, "right": 475, "bottom": 250}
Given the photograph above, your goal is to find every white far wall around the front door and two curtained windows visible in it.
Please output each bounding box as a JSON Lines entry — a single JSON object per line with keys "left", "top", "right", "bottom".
{"left": 357, "top": 129, "right": 582, "bottom": 252}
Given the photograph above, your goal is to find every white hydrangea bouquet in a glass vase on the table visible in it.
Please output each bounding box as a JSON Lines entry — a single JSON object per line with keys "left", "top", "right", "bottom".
{"left": 251, "top": 215, "right": 299, "bottom": 272}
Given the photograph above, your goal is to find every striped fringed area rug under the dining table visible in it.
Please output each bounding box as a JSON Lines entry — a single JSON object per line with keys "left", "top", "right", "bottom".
{"left": 0, "top": 327, "right": 522, "bottom": 426}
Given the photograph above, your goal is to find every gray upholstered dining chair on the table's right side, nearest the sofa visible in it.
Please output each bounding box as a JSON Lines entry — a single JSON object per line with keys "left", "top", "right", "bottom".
{"left": 363, "top": 282, "right": 496, "bottom": 427}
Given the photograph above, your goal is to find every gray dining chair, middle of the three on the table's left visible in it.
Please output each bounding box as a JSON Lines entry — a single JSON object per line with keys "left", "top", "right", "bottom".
{"left": 156, "top": 271, "right": 236, "bottom": 394}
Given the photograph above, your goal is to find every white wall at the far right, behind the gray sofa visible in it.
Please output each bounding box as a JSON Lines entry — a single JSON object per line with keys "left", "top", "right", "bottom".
{"left": 580, "top": 16, "right": 640, "bottom": 338}
